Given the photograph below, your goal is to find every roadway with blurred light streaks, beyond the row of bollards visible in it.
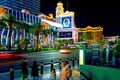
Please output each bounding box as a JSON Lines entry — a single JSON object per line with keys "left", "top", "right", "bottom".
{"left": 0, "top": 50, "right": 79, "bottom": 73}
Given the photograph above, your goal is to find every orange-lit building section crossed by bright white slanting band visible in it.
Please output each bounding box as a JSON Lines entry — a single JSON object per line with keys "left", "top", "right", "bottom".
{"left": 39, "top": 13, "right": 62, "bottom": 44}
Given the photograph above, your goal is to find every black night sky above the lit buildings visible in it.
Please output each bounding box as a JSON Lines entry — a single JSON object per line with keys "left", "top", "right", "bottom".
{"left": 41, "top": 0, "right": 120, "bottom": 36}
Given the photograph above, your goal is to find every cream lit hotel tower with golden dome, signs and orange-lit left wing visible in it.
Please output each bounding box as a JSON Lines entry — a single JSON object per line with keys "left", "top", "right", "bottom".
{"left": 39, "top": 2, "right": 78, "bottom": 42}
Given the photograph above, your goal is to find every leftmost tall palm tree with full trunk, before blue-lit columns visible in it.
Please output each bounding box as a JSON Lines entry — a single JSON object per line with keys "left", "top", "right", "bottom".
{"left": 2, "top": 14, "right": 18, "bottom": 50}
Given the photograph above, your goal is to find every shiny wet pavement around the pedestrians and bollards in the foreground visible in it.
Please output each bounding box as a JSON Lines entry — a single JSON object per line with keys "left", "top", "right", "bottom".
{"left": 0, "top": 61, "right": 80, "bottom": 80}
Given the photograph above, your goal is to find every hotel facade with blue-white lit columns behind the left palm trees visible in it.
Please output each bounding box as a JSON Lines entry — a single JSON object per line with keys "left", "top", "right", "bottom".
{"left": 0, "top": 6, "right": 41, "bottom": 45}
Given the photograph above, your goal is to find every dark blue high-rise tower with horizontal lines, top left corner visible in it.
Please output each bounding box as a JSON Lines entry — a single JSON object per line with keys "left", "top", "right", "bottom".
{"left": 0, "top": 0, "right": 40, "bottom": 15}
